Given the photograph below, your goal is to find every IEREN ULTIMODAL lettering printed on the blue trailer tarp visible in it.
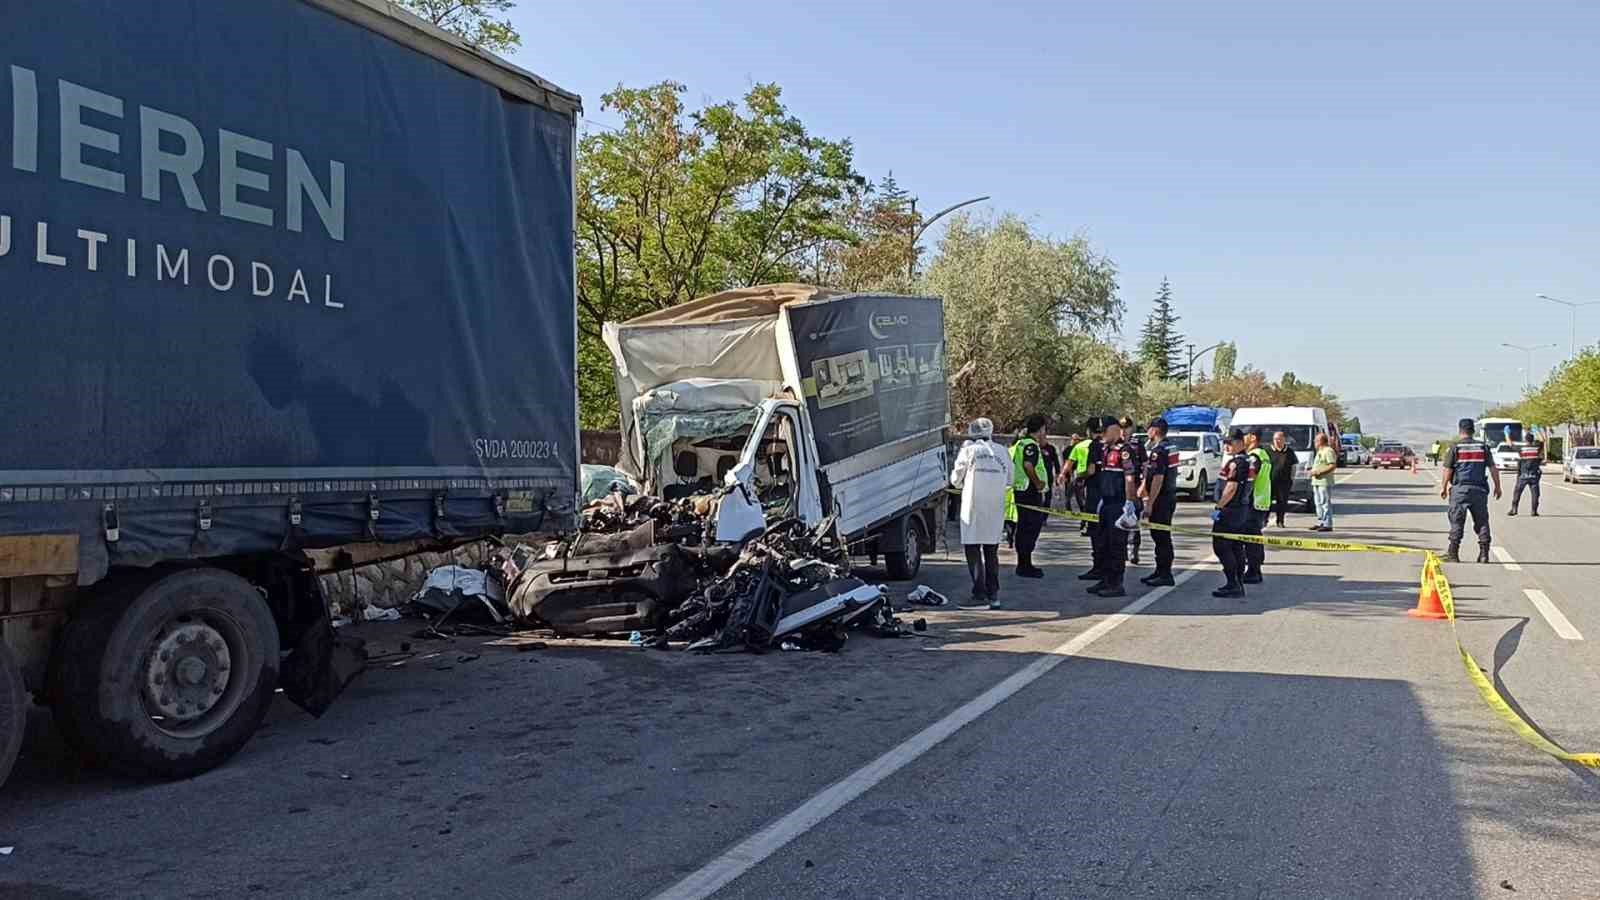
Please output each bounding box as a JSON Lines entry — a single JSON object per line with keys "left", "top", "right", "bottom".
{"left": 0, "top": 66, "right": 346, "bottom": 309}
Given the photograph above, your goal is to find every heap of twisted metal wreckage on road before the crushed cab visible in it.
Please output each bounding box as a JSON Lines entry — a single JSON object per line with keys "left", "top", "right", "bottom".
{"left": 416, "top": 485, "right": 923, "bottom": 652}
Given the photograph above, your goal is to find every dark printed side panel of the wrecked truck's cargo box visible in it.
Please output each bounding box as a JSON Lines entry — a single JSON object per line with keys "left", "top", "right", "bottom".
{"left": 784, "top": 295, "right": 949, "bottom": 468}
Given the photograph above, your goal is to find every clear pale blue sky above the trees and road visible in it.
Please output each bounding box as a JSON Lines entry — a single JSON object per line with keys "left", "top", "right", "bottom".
{"left": 515, "top": 0, "right": 1600, "bottom": 399}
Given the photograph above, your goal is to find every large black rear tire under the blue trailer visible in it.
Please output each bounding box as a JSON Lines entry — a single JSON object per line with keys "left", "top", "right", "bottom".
{"left": 51, "top": 569, "right": 278, "bottom": 778}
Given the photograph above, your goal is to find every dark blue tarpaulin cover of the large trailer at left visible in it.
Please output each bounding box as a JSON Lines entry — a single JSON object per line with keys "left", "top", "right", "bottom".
{"left": 0, "top": 0, "right": 578, "bottom": 582}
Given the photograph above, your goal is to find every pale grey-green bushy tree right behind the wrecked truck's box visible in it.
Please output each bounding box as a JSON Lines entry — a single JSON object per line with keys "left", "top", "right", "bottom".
{"left": 920, "top": 215, "right": 1138, "bottom": 428}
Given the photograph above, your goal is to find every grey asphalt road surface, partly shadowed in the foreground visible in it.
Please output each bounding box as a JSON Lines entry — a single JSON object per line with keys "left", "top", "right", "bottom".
{"left": 0, "top": 469, "right": 1600, "bottom": 898}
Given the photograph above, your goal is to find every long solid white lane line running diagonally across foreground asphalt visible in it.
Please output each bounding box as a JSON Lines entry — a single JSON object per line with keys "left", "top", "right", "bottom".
{"left": 654, "top": 562, "right": 1216, "bottom": 900}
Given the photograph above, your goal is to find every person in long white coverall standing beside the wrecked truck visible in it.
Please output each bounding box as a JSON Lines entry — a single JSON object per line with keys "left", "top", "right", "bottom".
{"left": 950, "top": 418, "right": 1011, "bottom": 610}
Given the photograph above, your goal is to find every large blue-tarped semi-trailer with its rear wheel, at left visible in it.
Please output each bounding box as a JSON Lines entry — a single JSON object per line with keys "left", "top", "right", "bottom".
{"left": 0, "top": 0, "right": 579, "bottom": 781}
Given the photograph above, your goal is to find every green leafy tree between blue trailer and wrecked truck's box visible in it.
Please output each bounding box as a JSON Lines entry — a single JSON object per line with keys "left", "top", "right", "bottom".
{"left": 578, "top": 82, "right": 866, "bottom": 428}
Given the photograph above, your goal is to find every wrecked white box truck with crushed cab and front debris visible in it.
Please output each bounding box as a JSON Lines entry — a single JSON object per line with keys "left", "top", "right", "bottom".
{"left": 509, "top": 285, "right": 949, "bottom": 645}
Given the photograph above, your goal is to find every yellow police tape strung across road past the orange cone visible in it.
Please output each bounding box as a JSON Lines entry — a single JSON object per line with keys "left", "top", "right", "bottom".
{"left": 992, "top": 492, "right": 1600, "bottom": 769}
